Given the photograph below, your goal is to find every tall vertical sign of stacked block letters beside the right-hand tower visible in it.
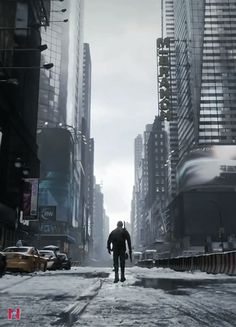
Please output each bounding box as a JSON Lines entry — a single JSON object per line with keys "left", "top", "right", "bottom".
{"left": 157, "top": 37, "right": 171, "bottom": 121}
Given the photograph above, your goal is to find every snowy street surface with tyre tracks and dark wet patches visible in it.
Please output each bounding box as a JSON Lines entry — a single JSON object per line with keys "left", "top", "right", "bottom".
{"left": 0, "top": 267, "right": 236, "bottom": 327}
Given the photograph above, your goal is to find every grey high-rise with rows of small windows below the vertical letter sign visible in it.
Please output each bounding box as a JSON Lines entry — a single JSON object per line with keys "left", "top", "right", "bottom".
{"left": 142, "top": 116, "right": 168, "bottom": 249}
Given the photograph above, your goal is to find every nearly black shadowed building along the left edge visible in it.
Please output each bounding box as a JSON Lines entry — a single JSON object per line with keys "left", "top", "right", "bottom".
{"left": 0, "top": 0, "right": 50, "bottom": 248}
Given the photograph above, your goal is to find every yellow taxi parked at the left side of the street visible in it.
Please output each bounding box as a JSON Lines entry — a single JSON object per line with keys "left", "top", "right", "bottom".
{"left": 3, "top": 246, "right": 47, "bottom": 272}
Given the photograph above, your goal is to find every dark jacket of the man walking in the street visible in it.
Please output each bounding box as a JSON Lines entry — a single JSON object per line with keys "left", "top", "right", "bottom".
{"left": 107, "top": 227, "right": 132, "bottom": 253}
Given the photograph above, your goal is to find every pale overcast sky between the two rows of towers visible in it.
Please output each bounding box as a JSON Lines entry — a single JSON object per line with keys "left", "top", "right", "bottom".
{"left": 84, "top": 0, "right": 161, "bottom": 229}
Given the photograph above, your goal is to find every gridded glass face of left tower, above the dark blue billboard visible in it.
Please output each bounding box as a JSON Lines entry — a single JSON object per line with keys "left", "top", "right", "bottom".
{"left": 38, "top": 1, "right": 69, "bottom": 127}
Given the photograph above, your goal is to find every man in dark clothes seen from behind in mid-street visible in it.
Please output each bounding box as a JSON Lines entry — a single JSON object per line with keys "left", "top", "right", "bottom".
{"left": 107, "top": 221, "right": 132, "bottom": 283}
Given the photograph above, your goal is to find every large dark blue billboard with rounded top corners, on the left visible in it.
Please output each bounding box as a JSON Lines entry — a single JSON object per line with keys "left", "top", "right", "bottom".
{"left": 38, "top": 128, "right": 74, "bottom": 222}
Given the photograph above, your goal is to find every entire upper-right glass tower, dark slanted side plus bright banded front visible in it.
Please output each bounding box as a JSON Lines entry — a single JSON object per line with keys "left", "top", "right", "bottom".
{"left": 174, "top": 0, "right": 236, "bottom": 154}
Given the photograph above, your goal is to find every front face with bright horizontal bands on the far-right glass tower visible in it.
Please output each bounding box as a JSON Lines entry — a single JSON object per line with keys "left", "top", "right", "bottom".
{"left": 199, "top": 0, "right": 236, "bottom": 144}
